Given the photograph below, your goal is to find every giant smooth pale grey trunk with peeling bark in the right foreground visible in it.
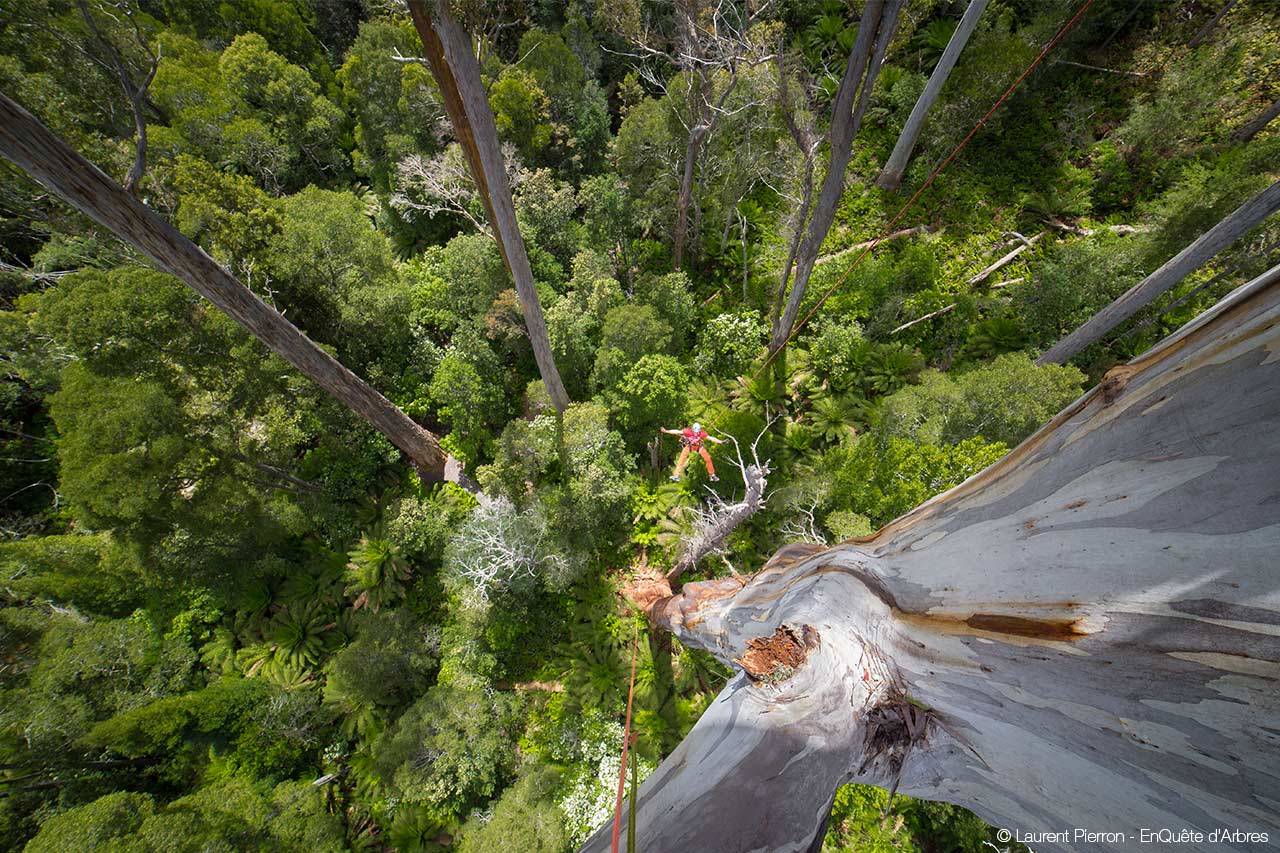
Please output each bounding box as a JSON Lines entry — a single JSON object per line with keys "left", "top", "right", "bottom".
{"left": 582, "top": 262, "right": 1280, "bottom": 853}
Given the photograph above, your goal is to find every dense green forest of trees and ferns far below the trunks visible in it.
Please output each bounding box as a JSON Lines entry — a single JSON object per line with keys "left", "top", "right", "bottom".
{"left": 0, "top": 0, "right": 1280, "bottom": 853}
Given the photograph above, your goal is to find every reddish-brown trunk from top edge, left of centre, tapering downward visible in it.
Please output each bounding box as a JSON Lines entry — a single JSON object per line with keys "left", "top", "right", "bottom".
{"left": 408, "top": 0, "right": 568, "bottom": 412}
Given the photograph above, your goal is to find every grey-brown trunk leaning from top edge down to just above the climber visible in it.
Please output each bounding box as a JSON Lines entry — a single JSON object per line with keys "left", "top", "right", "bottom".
{"left": 769, "top": 0, "right": 902, "bottom": 352}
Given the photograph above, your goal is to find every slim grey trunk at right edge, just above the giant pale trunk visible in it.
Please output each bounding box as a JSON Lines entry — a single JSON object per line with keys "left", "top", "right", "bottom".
{"left": 1036, "top": 181, "right": 1280, "bottom": 364}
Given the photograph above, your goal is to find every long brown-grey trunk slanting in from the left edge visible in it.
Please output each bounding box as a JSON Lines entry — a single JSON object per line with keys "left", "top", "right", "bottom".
{"left": 0, "top": 95, "right": 457, "bottom": 479}
